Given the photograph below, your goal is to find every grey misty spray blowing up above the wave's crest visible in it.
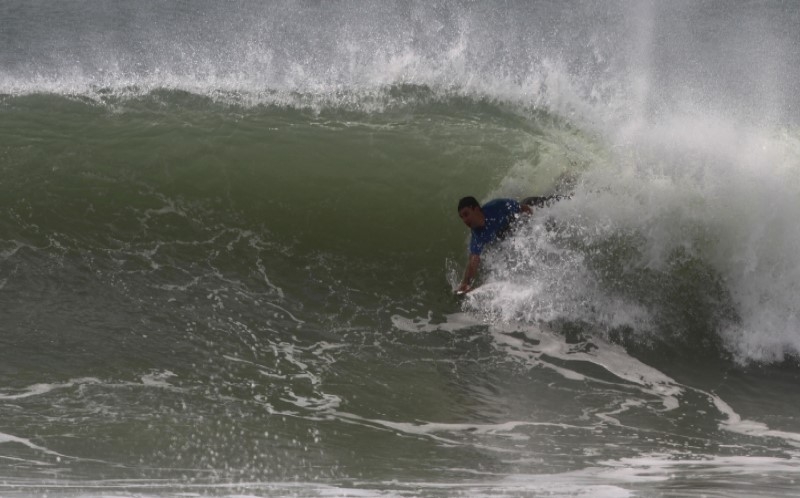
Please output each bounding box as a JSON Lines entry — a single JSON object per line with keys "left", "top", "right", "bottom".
{"left": 6, "top": 1, "right": 800, "bottom": 124}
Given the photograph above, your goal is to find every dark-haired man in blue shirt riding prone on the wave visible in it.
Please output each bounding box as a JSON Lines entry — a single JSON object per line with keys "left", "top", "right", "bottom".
{"left": 456, "top": 195, "right": 562, "bottom": 294}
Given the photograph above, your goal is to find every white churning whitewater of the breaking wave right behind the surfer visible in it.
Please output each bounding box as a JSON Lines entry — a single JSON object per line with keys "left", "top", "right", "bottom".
{"left": 468, "top": 116, "right": 800, "bottom": 362}
